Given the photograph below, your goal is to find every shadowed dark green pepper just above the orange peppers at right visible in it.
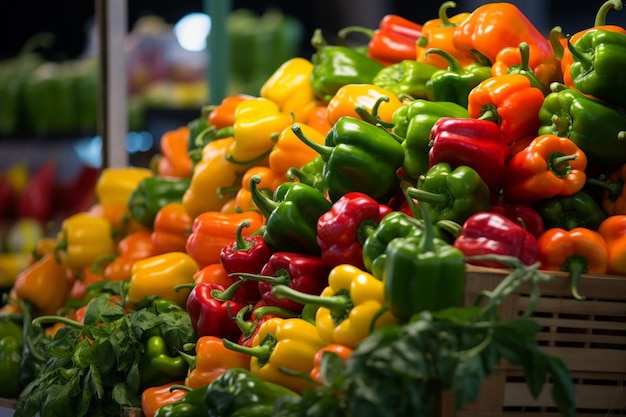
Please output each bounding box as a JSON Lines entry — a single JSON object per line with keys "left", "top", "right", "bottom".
{"left": 537, "top": 191, "right": 606, "bottom": 230}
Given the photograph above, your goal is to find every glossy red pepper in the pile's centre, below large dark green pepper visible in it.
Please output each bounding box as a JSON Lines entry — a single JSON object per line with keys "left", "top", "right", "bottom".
{"left": 317, "top": 192, "right": 392, "bottom": 269}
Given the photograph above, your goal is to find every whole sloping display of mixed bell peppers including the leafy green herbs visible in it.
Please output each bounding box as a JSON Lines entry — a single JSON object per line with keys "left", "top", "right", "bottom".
{"left": 0, "top": 0, "right": 626, "bottom": 417}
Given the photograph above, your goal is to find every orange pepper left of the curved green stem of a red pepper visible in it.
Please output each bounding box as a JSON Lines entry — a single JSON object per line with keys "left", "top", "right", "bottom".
{"left": 186, "top": 211, "right": 264, "bottom": 268}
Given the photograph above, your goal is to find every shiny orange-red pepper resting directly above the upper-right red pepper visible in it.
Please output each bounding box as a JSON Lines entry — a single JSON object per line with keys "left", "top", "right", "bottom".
{"left": 467, "top": 74, "right": 544, "bottom": 143}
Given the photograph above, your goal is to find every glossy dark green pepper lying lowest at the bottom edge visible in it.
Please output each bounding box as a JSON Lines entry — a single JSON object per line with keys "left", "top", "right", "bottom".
{"left": 204, "top": 368, "right": 297, "bottom": 417}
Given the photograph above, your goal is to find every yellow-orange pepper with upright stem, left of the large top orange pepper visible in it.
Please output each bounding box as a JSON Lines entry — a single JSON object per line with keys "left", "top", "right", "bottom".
{"left": 415, "top": 1, "right": 476, "bottom": 69}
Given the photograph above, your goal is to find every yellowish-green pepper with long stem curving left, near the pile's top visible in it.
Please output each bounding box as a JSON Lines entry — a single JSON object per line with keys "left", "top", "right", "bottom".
{"left": 425, "top": 48, "right": 491, "bottom": 108}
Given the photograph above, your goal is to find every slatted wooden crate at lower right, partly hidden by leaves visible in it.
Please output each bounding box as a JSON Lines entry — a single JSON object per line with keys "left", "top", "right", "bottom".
{"left": 442, "top": 266, "right": 626, "bottom": 417}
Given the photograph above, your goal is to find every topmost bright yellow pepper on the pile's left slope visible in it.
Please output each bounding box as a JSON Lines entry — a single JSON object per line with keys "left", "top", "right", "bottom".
{"left": 260, "top": 57, "right": 317, "bottom": 122}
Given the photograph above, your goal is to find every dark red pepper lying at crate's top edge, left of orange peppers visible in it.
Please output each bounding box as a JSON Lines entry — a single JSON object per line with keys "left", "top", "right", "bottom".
{"left": 454, "top": 212, "right": 538, "bottom": 268}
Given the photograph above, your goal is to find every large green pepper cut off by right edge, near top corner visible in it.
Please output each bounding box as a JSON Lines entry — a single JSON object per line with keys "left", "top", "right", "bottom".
{"left": 568, "top": 29, "right": 626, "bottom": 107}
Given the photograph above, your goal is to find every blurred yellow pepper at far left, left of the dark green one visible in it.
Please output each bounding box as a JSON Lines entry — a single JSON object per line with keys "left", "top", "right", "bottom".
{"left": 96, "top": 167, "right": 154, "bottom": 205}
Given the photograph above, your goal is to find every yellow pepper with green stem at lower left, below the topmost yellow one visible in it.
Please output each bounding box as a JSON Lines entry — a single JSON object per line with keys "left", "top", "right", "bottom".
{"left": 226, "top": 97, "right": 293, "bottom": 165}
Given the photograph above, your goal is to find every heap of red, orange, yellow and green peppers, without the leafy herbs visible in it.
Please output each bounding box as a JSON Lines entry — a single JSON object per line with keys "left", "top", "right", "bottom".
{"left": 0, "top": 0, "right": 626, "bottom": 416}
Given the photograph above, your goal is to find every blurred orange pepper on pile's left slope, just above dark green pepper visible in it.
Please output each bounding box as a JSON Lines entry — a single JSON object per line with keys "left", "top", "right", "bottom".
{"left": 156, "top": 126, "right": 192, "bottom": 178}
